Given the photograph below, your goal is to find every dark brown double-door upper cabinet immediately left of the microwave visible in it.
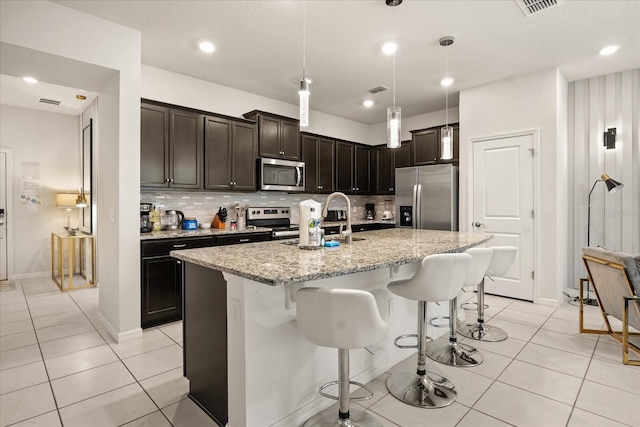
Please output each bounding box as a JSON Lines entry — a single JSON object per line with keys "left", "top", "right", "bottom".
{"left": 204, "top": 116, "right": 258, "bottom": 191}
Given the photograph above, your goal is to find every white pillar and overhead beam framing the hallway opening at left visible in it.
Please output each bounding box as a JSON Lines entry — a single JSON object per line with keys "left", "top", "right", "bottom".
{"left": 0, "top": 1, "right": 141, "bottom": 339}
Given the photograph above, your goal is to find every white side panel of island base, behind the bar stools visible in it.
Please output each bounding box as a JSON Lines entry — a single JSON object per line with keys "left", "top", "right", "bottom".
{"left": 222, "top": 264, "right": 447, "bottom": 427}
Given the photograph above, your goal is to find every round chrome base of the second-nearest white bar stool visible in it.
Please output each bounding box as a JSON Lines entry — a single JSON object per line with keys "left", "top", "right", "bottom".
{"left": 387, "top": 372, "right": 458, "bottom": 408}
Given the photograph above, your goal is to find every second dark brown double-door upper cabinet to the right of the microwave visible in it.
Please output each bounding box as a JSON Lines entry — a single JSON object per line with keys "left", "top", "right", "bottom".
{"left": 336, "top": 141, "right": 371, "bottom": 194}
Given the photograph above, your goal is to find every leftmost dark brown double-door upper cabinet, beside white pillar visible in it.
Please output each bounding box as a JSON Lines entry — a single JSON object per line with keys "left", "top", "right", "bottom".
{"left": 140, "top": 102, "right": 204, "bottom": 189}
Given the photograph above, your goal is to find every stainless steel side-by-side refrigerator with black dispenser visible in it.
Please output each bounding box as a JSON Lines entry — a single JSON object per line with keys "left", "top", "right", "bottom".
{"left": 396, "top": 164, "right": 458, "bottom": 231}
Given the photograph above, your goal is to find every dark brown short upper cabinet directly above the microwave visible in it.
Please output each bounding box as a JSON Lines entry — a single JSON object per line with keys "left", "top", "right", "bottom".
{"left": 244, "top": 110, "right": 301, "bottom": 160}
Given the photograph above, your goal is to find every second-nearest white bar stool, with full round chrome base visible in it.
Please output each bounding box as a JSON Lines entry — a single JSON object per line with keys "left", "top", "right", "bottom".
{"left": 387, "top": 254, "right": 471, "bottom": 408}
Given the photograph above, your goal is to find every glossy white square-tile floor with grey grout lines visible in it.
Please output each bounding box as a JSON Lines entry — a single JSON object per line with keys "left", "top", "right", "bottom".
{"left": 0, "top": 279, "right": 640, "bottom": 427}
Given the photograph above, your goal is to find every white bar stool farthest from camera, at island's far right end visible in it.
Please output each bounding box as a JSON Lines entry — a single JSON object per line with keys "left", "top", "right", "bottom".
{"left": 458, "top": 246, "right": 518, "bottom": 342}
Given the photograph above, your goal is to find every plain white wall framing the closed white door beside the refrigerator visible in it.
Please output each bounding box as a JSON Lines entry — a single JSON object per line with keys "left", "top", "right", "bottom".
{"left": 459, "top": 69, "right": 568, "bottom": 302}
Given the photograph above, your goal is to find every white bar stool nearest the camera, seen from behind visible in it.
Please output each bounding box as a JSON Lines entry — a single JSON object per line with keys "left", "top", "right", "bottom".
{"left": 296, "top": 287, "right": 389, "bottom": 427}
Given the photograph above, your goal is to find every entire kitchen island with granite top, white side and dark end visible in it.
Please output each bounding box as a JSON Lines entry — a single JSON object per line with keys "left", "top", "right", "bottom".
{"left": 171, "top": 229, "right": 491, "bottom": 427}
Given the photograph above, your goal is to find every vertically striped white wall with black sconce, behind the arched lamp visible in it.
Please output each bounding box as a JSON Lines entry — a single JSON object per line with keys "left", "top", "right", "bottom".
{"left": 568, "top": 69, "right": 640, "bottom": 288}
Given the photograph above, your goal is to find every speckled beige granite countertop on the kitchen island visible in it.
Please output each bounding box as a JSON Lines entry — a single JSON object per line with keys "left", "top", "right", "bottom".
{"left": 171, "top": 228, "right": 493, "bottom": 285}
